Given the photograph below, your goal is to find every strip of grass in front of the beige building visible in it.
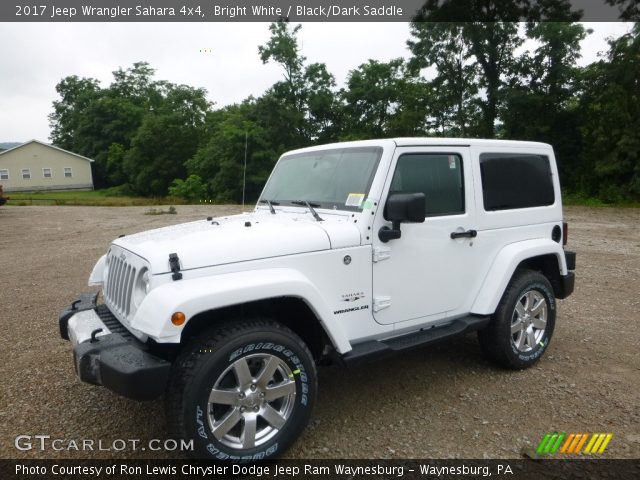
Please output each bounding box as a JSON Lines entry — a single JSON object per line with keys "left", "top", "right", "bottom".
{"left": 5, "top": 188, "right": 185, "bottom": 207}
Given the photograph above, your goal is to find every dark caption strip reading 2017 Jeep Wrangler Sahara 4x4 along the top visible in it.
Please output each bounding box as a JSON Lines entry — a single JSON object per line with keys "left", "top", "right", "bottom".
{"left": 0, "top": 0, "right": 638, "bottom": 22}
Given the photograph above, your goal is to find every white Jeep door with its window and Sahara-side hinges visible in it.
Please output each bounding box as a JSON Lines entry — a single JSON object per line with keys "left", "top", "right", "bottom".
{"left": 373, "top": 147, "right": 475, "bottom": 324}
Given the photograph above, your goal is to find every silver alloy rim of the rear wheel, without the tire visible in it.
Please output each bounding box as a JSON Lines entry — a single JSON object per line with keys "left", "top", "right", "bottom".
{"left": 511, "top": 290, "right": 547, "bottom": 352}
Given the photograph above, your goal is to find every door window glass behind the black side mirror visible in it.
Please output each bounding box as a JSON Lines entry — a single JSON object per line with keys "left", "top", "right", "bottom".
{"left": 390, "top": 153, "right": 464, "bottom": 217}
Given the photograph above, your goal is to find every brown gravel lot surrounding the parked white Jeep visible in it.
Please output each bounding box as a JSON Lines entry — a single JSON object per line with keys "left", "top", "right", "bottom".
{"left": 0, "top": 206, "right": 640, "bottom": 459}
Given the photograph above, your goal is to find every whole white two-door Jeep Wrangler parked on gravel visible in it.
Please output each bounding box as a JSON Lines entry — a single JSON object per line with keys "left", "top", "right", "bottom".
{"left": 59, "top": 138, "right": 575, "bottom": 460}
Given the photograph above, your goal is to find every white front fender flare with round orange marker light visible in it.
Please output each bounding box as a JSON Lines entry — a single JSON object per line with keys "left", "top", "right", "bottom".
{"left": 131, "top": 268, "right": 351, "bottom": 353}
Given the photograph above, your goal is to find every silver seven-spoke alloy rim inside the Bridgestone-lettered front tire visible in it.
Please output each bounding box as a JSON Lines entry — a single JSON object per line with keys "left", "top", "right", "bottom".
{"left": 208, "top": 353, "right": 296, "bottom": 449}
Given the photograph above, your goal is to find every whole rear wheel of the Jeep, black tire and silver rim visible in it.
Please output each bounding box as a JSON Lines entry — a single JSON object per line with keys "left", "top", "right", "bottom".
{"left": 478, "top": 270, "right": 556, "bottom": 369}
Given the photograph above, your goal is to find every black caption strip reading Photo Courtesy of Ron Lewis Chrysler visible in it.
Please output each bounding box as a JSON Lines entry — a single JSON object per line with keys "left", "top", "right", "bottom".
{"left": 0, "top": 459, "right": 640, "bottom": 480}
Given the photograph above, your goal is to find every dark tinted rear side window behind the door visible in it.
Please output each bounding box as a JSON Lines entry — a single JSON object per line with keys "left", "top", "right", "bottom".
{"left": 480, "top": 153, "right": 555, "bottom": 211}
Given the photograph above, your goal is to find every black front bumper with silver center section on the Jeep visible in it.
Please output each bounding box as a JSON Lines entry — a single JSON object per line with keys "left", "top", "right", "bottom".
{"left": 58, "top": 293, "right": 171, "bottom": 400}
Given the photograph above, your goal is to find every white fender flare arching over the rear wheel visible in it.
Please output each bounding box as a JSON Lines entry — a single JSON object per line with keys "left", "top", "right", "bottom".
{"left": 471, "top": 238, "right": 567, "bottom": 315}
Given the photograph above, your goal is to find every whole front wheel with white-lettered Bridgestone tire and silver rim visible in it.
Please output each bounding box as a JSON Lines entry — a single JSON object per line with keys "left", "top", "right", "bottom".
{"left": 167, "top": 320, "right": 317, "bottom": 461}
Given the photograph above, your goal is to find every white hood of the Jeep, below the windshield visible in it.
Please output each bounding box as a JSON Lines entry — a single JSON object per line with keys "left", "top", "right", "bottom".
{"left": 113, "top": 213, "right": 360, "bottom": 275}
